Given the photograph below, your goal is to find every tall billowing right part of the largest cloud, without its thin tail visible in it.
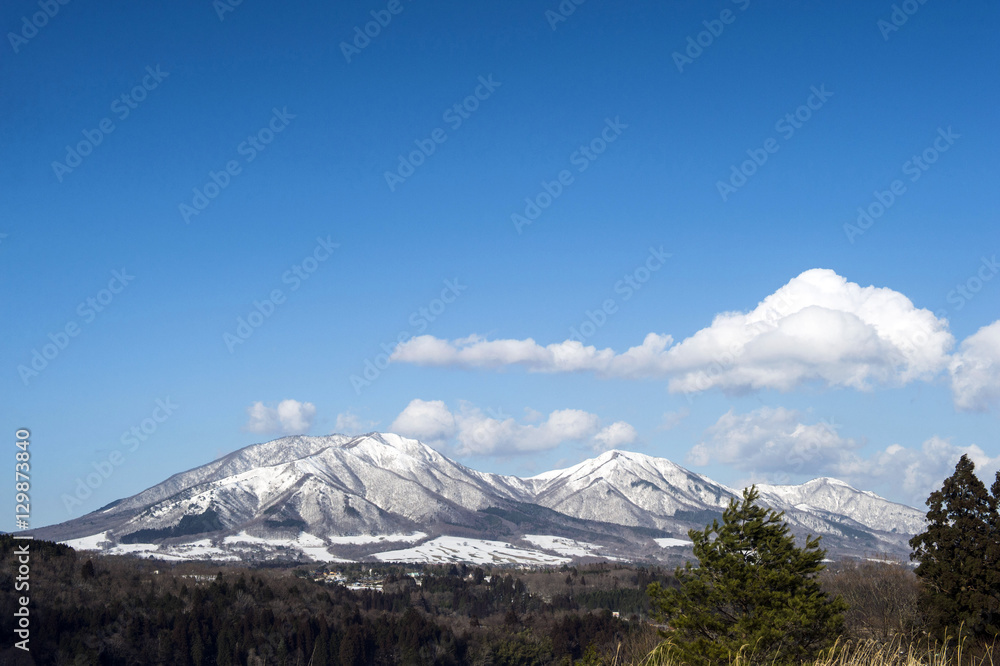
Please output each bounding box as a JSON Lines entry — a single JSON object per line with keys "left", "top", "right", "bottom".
{"left": 670, "top": 269, "right": 954, "bottom": 391}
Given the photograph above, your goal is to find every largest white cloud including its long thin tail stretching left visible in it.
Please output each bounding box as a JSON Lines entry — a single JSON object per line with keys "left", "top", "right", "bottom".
{"left": 392, "top": 269, "right": 954, "bottom": 393}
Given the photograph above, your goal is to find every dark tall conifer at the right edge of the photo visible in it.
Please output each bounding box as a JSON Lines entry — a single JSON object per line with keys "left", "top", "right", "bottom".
{"left": 910, "top": 455, "right": 1000, "bottom": 639}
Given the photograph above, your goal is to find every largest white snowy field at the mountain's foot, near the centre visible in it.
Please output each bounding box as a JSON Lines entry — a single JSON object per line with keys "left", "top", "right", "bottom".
{"left": 375, "top": 536, "right": 571, "bottom": 566}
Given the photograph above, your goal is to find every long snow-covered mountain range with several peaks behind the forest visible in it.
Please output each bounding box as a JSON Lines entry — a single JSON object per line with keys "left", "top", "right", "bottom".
{"left": 36, "top": 433, "right": 923, "bottom": 563}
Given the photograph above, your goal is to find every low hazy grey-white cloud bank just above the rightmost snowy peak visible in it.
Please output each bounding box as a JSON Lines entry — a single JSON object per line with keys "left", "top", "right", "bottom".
{"left": 687, "top": 407, "right": 1000, "bottom": 505}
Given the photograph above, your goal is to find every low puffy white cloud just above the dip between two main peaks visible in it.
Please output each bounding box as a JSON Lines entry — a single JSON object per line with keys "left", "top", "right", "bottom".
{"left": 390, "top": 399, "right": 637, "bottom": 456}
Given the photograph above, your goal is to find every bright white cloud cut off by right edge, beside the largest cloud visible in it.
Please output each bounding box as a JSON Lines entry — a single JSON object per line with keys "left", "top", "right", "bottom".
{"left": 948, "top": 321, "right": 1000, "bottom": 412}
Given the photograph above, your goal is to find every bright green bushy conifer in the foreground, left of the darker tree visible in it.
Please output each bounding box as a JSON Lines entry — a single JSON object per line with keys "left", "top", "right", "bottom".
{"left": 649, "top": 487, "right": 847, "bottom": 664}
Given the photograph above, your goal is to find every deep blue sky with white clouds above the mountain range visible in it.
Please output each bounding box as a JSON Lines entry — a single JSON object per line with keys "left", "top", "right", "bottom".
{"left": 0, "top": 0, "right": 1000, "bottom": 529}
